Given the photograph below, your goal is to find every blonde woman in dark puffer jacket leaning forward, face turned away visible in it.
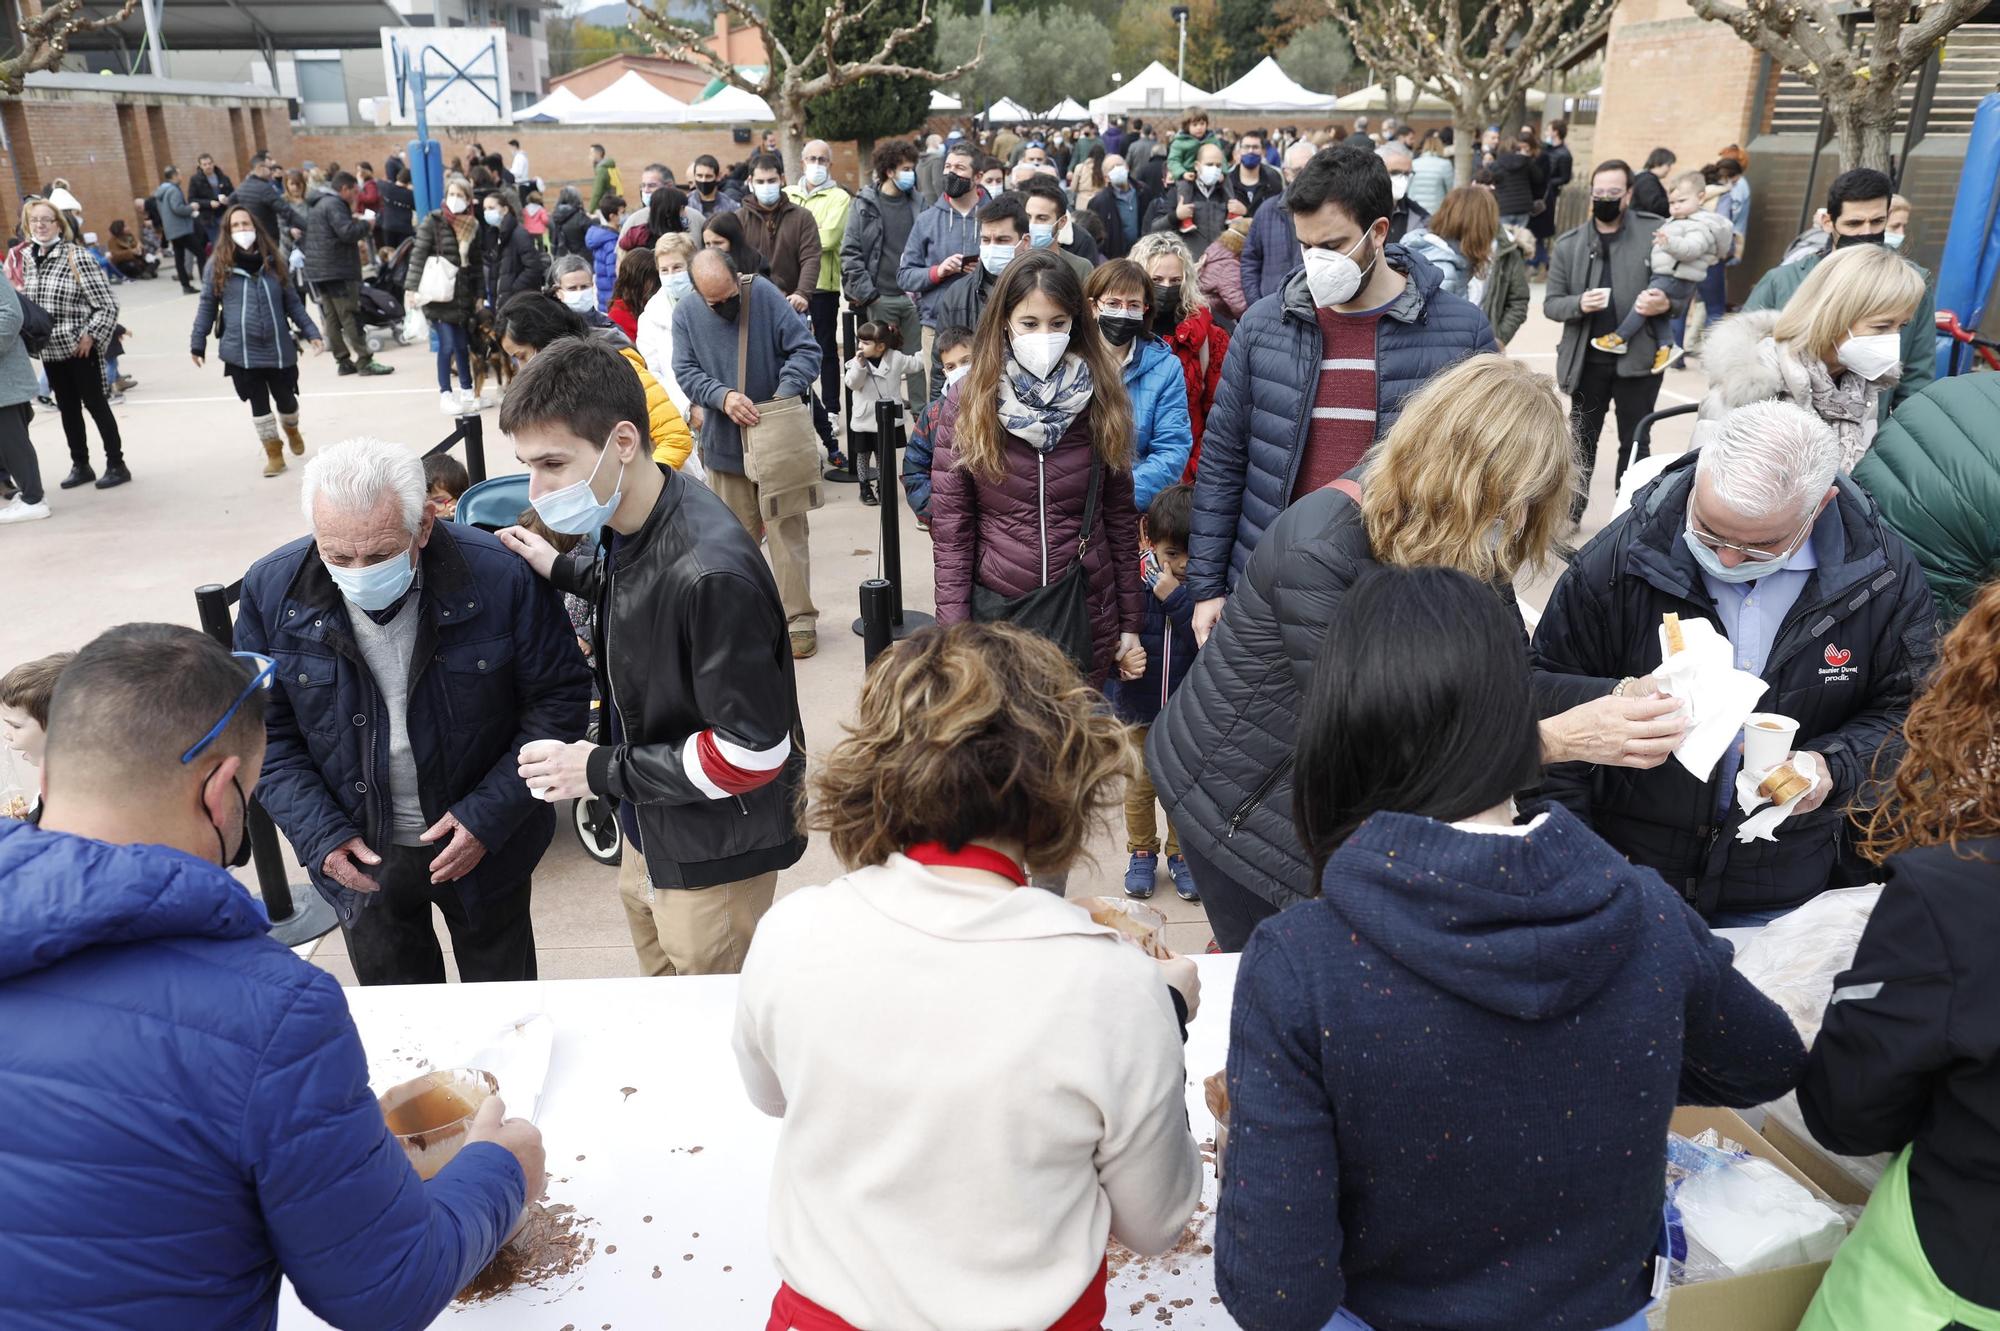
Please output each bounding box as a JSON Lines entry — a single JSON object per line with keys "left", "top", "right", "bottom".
{"left": 1146, "top": 354, "right": 1682, "bottom": 951}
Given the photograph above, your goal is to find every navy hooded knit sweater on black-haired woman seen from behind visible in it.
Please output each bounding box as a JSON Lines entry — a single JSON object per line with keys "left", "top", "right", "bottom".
{"left": 1216, "top": 809, "right": 1806, "bottom": 1331}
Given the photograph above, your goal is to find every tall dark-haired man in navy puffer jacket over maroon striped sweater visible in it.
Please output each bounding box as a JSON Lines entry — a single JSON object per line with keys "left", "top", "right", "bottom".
{"left": 1188, "top": 148, "right": 1498, "bottom": 640}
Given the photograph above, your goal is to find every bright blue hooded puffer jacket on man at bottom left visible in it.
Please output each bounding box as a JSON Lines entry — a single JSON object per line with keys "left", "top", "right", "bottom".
{"left": 0, "top": 819, "right": 526, "bottom": 1331}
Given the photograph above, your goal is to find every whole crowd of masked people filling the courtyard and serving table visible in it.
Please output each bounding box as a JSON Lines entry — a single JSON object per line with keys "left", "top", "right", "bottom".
{"left": 0, "top": 100, "right": 2000, "bottom": 1331}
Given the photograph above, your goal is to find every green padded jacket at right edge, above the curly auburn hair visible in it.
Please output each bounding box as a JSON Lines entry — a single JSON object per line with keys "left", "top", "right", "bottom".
{"left": 1854, "top": 374, "right": 2000, "bottom": 634}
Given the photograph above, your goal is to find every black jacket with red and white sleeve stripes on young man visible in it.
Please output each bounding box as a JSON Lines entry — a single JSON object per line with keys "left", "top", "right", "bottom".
{"left": 552, "top": 461, "right": 806, "bottom": 887}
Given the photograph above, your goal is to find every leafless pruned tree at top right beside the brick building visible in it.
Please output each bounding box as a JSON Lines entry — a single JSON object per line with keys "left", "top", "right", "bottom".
{"left": 1688, "top": 0, "right": 1986, "bottom": 172}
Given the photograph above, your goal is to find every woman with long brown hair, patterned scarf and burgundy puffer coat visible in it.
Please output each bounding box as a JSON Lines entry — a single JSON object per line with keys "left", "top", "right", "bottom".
{"left": 930, "top": 250, "right": 1146, "bottom": 683}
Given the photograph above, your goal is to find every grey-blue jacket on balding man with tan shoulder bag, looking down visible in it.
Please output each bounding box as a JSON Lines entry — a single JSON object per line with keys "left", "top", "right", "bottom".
{"left": 674, "top": 278, "right": 820, "bottom": 476}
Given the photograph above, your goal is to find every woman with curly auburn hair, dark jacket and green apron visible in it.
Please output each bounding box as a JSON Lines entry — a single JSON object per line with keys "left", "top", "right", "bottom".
{"left": 1798, "top": 582, "right": 2000, "bottom": 1331}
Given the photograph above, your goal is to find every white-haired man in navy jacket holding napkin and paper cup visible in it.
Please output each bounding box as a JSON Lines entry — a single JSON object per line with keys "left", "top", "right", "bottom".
{"left": 1534, "top": 402, "right": 1936, "bottom": 927}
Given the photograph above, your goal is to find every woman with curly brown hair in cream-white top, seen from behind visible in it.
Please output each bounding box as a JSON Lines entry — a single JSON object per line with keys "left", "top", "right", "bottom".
{"left": 734, "top": 623, "right": 1202, "bottom": 1331}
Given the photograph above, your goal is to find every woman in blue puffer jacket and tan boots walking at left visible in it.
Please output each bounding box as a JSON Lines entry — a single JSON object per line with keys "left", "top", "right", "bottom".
{"left": 188, "top": 208, "right": 326, "bottom": 476}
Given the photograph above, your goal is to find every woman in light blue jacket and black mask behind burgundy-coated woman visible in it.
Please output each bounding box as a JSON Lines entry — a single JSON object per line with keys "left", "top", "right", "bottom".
{"left": 1084, "top": 260, "right": 1194, "bottom": 514}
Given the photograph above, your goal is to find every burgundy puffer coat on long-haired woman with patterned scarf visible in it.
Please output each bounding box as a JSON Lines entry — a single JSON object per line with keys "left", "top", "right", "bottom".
{"left": 930, "top": 386, "right": 1146, "bottom": 685}
